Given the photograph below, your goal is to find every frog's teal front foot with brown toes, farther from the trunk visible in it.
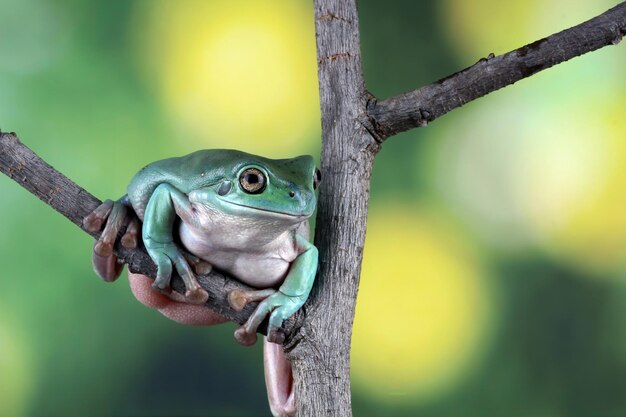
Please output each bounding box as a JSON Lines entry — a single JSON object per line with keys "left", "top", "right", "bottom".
{"left": 144, "top": 237, "right": 209, "bottom": 304}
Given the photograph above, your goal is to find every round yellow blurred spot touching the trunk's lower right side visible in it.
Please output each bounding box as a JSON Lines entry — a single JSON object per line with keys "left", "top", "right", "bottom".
{"left": 352, "top": 207, "right": 493, "bottom": 402}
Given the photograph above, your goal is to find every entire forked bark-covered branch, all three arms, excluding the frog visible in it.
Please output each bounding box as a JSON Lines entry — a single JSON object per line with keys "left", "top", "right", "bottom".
{"left": 0, "top": 0, "right": 626, "bottom": 417}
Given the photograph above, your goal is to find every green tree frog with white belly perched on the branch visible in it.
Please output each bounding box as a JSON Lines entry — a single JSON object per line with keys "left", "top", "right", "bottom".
{"left": 83, "top": 149, "right": 321, "bottom": 345}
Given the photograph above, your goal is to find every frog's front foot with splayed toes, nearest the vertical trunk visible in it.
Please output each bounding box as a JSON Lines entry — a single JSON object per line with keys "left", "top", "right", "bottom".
{"left": 228, "top": 289, "right": 306, "bottom": 346}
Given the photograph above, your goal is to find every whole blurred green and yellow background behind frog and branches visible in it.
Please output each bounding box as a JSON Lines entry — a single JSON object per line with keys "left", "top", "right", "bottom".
{"left": 0, "top": 0, "right": 626, "bottom": 417}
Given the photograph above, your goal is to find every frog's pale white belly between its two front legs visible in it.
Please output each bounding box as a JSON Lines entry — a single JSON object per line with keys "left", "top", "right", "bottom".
{"left": 180, "top": 223, "right": 298, "bottom": 288}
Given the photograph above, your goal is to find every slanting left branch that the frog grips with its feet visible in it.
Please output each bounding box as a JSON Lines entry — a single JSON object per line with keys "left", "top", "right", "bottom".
{"left": 0, "top": 132, "right": 296, "bottom": 343}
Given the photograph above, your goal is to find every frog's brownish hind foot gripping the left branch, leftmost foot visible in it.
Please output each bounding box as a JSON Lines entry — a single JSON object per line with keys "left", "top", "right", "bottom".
{"left": 83, "top": 200, "right": 141, "bottom": 281}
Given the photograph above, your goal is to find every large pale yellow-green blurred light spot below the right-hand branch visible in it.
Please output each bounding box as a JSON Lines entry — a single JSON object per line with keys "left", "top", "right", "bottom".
{"left": 428, "top": 83, "right": 626, "bottom": 279}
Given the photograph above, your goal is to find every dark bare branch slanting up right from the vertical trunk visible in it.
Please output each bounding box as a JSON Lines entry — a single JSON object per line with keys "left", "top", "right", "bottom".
{"left": 367, "top": 2, "right": 626, "bottom": 140}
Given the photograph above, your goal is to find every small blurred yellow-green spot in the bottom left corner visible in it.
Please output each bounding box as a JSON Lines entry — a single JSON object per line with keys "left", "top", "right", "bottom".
{"left": 0, "top": 315, "right": 33, "bottom": 417}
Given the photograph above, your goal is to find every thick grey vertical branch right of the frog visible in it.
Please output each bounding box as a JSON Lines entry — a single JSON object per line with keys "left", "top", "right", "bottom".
{"left": 287, "top": 0, "right": 378, "bottom": 417}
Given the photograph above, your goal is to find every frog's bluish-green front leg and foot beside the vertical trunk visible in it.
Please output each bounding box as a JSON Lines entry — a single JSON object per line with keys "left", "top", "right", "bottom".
{"left": 229, "top": 234, "right": 318, "bottom": 346}
